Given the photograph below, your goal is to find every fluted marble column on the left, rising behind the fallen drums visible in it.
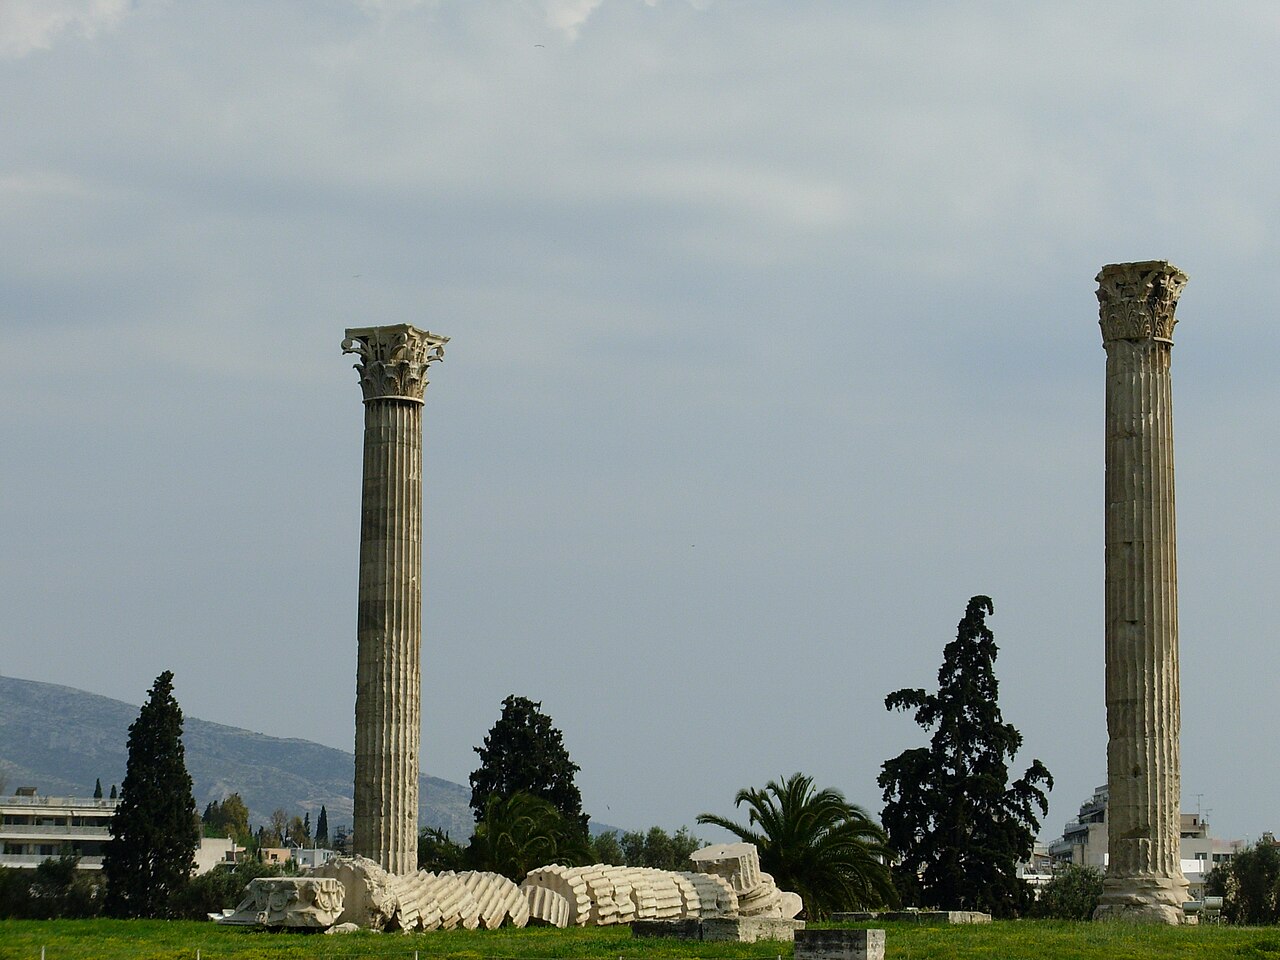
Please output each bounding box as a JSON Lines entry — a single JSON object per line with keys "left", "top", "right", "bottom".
{"left": 342, "top": 324, "right": 448, "bottom": 874}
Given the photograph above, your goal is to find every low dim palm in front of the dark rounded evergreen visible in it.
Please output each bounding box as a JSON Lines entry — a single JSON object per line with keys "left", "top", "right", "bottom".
{"left": 465, "top": 790, "right": 591, "bottom": 883}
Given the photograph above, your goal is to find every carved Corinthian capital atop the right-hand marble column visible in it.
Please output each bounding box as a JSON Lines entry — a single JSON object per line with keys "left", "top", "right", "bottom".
{"left": 1094, "top": 260, "right": 1187, "bottom": 343}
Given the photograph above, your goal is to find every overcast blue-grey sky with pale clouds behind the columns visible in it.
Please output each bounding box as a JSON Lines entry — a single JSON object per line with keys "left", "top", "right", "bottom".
{"left": 0, "top": 0, "right": 1280, "bottom": 838}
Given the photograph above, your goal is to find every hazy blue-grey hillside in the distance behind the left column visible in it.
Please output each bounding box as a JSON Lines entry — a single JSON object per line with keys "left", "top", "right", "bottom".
{"left": 0, "top": 676, "right": 472, "bottom": 842}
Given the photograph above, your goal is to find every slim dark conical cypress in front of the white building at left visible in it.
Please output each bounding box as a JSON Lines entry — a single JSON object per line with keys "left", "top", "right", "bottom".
{"left": 102, "top": 671, "right": 200, "bottom": 918}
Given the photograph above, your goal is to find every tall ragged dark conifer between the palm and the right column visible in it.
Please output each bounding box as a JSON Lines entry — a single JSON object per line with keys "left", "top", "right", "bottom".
{"left": 879, "top": 596, "right": 1053, "bottom": 916}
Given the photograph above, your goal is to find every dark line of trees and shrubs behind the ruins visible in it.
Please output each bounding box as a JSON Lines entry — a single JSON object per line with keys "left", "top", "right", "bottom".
{"left": 0, "top": 595, "right": 1280, "bottom": 923}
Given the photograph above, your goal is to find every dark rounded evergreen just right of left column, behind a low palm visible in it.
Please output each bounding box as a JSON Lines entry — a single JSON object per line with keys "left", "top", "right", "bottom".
{"left": 471, "top": 695, "right": 589, "bottom": 841}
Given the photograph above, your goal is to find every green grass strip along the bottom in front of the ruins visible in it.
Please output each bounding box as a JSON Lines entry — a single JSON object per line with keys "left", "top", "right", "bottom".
{"left": 0, "top": 920, "right": 1280, "bottom": 960}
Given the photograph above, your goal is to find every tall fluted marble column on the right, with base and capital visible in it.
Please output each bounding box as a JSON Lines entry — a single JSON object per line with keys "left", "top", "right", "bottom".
{"left": 1094, "top": 260, "right": 1187, "bottom": 923}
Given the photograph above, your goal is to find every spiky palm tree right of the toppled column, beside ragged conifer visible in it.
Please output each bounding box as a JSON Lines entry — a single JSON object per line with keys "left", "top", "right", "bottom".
{"left": 698, "top": 773, "right": 896, "bottom": 919}
